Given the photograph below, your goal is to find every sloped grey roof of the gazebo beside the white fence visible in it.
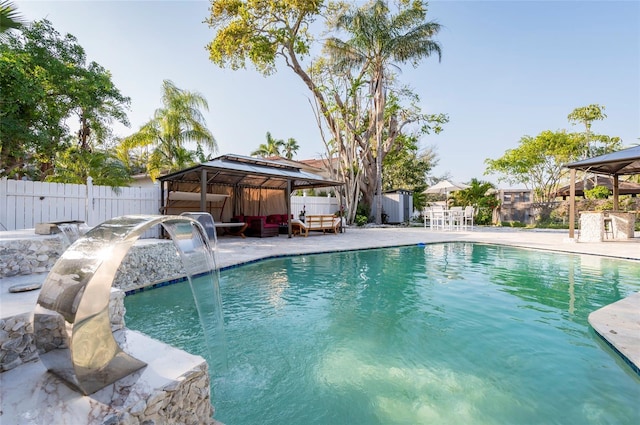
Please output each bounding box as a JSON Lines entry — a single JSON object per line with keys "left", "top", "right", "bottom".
{"left": 159, "top": 154, "right": 343, "bottom": 191}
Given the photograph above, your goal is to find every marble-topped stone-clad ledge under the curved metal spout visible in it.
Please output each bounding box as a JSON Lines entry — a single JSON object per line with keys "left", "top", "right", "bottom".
{"left": 0, "top": 329, "right": 215, "bottom": 425}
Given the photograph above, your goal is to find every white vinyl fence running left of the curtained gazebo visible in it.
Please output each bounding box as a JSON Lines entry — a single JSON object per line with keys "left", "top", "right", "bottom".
{"left": 0, "top": 178, "right": 160, "bottom": 231}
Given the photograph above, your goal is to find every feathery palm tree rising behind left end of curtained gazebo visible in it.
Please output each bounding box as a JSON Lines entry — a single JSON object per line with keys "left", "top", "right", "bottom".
{"left": 119, "top": 80, "right": 218, "bottom": 180}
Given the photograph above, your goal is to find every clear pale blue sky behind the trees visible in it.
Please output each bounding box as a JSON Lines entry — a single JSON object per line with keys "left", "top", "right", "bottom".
{"left": 14, "top": 0, "right": 640, "bottom": 187}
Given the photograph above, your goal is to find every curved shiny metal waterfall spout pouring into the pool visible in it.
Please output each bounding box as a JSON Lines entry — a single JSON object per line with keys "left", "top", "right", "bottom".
{"left": 34, "top": 215, "right": 226, "bottom": 395}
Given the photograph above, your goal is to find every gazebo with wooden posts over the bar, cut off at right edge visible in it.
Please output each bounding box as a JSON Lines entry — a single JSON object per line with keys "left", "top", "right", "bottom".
{"left": 566, "top": 146, "right": 640, "bottom": 239}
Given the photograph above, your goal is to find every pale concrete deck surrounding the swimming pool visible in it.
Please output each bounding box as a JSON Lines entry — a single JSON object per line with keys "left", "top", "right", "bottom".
{"left": 0, "top": 227, "right": 640, "bottom": 371}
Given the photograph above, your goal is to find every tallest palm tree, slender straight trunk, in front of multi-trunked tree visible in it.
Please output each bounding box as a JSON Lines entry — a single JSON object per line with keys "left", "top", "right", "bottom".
{"left": 325, "top": 0, "right": 441, "bottom": 224}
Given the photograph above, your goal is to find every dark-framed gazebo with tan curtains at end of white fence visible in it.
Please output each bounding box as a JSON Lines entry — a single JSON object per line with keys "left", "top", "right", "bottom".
{"left": 159, "top": 154, "right": 343, "bottom": 236}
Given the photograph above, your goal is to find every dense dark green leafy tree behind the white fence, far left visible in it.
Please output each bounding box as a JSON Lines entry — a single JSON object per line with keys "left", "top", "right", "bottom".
{"left": 0, "top": 20, "right": 130, "bottom": 179}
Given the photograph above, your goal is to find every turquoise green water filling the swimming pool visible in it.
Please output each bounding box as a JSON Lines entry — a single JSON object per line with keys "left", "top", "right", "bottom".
{"left": 125, "top": 243, "right": 640, "bottom": 425}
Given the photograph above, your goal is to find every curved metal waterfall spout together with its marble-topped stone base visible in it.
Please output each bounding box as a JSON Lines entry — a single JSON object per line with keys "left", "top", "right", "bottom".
{"left": 0, "top": 216, "right": 226, "bottom": 424}
